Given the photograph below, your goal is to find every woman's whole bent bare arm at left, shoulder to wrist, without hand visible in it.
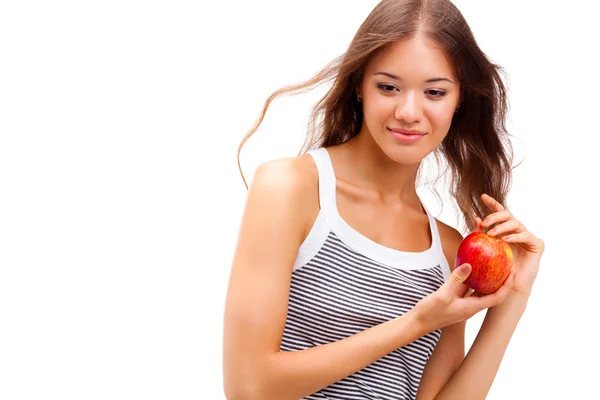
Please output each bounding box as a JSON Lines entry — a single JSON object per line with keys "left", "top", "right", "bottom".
{"left": 223, "top": 160, "right": 427, "bottom": 400}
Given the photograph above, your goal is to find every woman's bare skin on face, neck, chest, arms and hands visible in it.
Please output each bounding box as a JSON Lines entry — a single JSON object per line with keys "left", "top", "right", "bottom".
{"left": 223, "top": 37, "right": 543, "bottom": 400}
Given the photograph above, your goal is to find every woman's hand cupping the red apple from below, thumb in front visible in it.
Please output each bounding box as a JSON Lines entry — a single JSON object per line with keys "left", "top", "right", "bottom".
{"left": 411, "top": 264, "right": 515, "bottom": 333}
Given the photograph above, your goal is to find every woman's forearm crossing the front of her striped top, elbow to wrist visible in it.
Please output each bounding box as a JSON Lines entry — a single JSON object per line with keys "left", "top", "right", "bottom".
{"left": 249, "top": 311, "right": 426, "bottom": 400}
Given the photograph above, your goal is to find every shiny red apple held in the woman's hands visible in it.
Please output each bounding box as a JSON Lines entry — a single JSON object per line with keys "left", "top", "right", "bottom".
{"left": 454, "top": 232, "right": 513, "bottom": 294}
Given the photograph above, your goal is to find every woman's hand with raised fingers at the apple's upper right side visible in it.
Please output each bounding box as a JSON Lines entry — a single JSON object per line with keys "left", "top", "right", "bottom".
{"left": 473, "top": 193, "right": 544, "bottom": 297}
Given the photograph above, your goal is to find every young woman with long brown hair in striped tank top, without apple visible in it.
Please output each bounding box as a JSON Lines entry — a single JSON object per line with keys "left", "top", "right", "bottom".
{"left": 223, "top": 0, "right": 544, "bottom": 400}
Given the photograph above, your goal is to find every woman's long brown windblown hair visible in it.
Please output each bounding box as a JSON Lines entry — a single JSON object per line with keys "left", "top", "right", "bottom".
{"left": 238, "top": 0, "right": 513, "bottom": 236}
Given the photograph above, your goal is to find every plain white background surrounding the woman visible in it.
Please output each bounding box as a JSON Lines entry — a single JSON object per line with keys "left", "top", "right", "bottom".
{"left": 0, "top": 0, "right": 600, "bottom": 400}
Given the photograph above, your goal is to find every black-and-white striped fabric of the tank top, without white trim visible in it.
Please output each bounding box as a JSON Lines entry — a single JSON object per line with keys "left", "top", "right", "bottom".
{"left": 281, "top": 231, "right": 444, "bottom": 400}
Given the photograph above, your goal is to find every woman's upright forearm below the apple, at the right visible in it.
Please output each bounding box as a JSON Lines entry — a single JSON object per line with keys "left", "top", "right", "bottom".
{"left": 436, "top": 293, "right": 528, "bottom": 400}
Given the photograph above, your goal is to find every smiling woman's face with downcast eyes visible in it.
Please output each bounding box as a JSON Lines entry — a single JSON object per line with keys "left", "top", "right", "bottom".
{"left": 359, "top": 36, "right": 460, "bottom": 164}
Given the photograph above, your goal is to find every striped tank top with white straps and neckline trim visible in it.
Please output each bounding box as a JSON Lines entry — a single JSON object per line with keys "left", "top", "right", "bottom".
{"left": 280, "top": 148, "right": 450, "bottom": 400}
